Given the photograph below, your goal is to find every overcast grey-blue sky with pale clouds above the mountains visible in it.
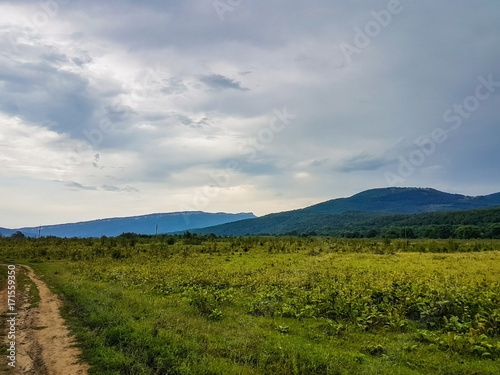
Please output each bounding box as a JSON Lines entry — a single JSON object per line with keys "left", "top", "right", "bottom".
{"left": 0, "top": 0, "right": 500, "bottom": 228}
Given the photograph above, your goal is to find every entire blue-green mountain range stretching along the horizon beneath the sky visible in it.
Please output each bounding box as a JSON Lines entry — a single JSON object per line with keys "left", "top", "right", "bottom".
{"left": 0, "top": 188, "right": 500, "bottom": 238}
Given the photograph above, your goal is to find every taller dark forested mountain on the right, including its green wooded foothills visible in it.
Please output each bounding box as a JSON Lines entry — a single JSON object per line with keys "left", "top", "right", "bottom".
{"left": 192, "top": 188, "right": 500, "bottom": 238}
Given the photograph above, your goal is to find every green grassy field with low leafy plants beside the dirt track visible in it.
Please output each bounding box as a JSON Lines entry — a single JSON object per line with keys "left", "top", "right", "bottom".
{"left": 0, "top": 235, "right": 500, "bottom": 375}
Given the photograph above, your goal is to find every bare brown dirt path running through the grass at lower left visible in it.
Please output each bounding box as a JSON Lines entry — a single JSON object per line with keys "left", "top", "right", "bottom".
{"left": 0, "top": 266, "right": 88, "bottom": 375}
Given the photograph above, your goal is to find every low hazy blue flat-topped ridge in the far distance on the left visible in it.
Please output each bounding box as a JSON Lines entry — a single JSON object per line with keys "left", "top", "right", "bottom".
{"left": 0, "top": 211, "right": 255, "bottom": 237}
